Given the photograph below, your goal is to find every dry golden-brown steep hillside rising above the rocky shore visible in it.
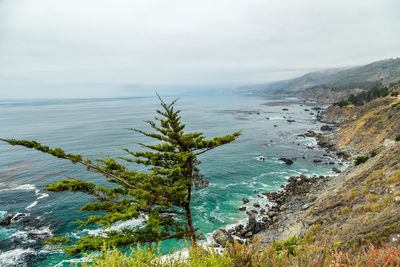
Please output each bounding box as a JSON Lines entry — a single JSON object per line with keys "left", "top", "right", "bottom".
{"left": 262, "top": 97, "right": 400, "bottom": 251}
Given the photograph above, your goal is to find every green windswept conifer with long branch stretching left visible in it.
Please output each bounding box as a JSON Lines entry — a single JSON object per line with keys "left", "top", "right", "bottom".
{"left": 0, "top": 97, "right": 240, "bottom": 255}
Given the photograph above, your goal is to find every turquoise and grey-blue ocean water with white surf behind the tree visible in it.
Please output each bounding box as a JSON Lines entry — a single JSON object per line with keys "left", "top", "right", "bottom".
{"left": 0, "top": 96, "right": 340, "bottom": 266}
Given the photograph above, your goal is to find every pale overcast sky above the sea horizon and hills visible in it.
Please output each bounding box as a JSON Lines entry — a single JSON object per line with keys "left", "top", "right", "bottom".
{"left": 0, "top": 0, "right": 400, "bottom": 98}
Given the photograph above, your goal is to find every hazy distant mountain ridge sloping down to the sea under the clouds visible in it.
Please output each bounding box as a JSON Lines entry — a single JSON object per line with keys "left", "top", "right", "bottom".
{"left": 235, "top": 58, "right": 400, "bottom": 100}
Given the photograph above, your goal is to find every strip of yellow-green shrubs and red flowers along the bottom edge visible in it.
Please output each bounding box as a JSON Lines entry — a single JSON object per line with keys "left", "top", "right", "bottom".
{"left": 82, "top": 236, "right": 400, "bottom": 267}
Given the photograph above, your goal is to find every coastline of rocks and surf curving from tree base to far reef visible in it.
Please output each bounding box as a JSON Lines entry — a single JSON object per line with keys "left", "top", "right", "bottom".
{"left": 208, "top": 100, "right": 355, "bottom": 247}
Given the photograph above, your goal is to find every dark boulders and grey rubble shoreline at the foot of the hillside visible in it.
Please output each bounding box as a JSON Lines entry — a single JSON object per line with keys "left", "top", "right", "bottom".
{"left": 213, "top": 109, "right": 358, "bottom": 247}
